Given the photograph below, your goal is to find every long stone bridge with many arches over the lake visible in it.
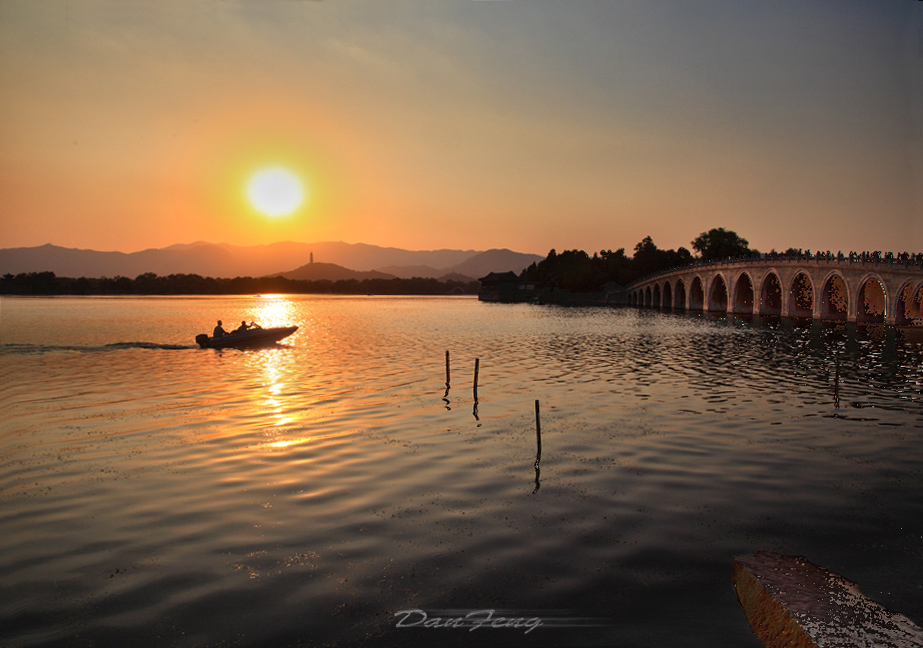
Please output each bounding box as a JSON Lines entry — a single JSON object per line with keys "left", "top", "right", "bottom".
{"left": 626, "top": 254, "right": 923, "bottom": 326}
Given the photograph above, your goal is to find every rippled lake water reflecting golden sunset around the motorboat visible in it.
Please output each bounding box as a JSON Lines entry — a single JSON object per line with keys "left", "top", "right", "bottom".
{"left": 0, "top": 296, "right": 923, "bottom": 648}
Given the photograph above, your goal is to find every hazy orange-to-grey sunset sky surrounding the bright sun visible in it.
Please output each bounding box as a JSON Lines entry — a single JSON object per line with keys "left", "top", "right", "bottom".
{"left": 0, "top": 0, "right": 923, "bottom": 254}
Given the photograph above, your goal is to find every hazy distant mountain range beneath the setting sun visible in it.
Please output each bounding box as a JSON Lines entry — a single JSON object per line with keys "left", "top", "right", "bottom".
{"left": 0, "top": 242, "right": 543, "bottom": 280}
